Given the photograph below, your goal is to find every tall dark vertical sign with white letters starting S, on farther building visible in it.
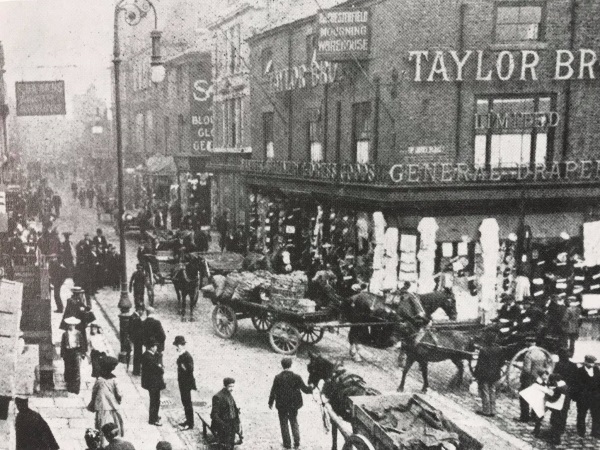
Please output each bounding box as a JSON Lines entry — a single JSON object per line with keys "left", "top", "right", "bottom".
{"left": 190, "top": 58, "right": 213, "bottom": 153}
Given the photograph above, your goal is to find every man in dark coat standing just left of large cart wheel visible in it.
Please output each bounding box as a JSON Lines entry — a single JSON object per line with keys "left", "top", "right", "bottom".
{"left": 473, "top": 333, "right": 505, "bottom": 417}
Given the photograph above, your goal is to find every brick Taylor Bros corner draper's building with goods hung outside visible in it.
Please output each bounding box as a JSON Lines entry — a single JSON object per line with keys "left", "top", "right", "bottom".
{"left": 243, "top": 0, "right": 600, "bottom": 320}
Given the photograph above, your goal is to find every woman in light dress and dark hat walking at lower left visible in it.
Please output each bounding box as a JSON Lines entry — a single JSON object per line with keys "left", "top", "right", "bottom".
{"left": 88, "top": 356, "right": 124, "bottom": 444}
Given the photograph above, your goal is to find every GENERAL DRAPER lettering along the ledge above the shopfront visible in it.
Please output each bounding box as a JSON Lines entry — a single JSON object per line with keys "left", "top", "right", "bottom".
{"left": 389, "top": 160, "right": 600, "bottom": 184}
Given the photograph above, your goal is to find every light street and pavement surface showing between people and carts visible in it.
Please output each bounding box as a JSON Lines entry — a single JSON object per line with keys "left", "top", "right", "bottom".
{"left": 22, "top": 180, "right": 600, "bottom": 450}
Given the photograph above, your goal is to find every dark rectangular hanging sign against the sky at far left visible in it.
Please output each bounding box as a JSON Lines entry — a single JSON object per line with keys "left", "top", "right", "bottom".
{"left": 15, "top": 80, "right": 67, "bottom": 116}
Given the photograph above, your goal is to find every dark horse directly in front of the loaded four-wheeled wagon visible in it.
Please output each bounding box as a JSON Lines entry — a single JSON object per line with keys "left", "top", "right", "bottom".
{"left": 341, "top": 291, "right": 457, "bottom": 361}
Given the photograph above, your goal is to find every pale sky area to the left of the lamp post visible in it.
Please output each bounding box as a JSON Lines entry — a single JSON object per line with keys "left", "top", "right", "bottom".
{"left": 0, "top": 0, "right": 114, "bottom": 111}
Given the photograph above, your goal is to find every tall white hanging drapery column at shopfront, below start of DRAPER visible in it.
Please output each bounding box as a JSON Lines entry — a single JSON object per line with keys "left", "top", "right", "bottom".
{"left": 479, "top": 219, "right": 500, "bottom": 325}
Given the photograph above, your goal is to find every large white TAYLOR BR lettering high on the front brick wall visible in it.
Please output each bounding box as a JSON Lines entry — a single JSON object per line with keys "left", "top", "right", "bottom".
{"left": 408, "top": 49, "right": 600, "bottom": 81}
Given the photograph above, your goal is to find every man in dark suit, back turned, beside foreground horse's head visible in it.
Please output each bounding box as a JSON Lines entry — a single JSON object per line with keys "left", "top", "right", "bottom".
{"left": 269, "top": 357, "right": 312, "bottom": 448}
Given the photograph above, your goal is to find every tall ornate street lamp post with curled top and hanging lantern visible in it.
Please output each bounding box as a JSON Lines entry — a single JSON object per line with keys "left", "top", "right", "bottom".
{"left": 113, "top": 0, "right": 165, "bottom": 361}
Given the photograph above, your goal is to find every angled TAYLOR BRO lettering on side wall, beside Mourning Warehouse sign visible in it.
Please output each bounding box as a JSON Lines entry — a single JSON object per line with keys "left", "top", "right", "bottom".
{"left": 266, "top": 60, "right": 341, "bottom": 92}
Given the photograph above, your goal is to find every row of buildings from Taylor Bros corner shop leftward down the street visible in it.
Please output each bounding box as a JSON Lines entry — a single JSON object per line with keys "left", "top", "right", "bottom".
{"left": 118, "top": 0, "right": 600, "bottom": 316}
